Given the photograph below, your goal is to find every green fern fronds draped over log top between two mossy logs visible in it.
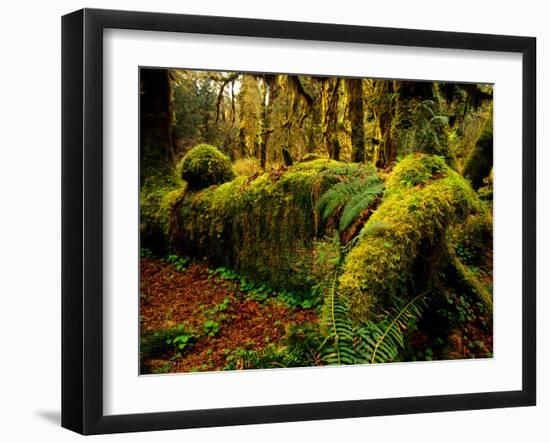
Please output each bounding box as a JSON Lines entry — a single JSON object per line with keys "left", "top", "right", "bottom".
{"left": 316, "top": 175, "right": 384, "bottom": 231}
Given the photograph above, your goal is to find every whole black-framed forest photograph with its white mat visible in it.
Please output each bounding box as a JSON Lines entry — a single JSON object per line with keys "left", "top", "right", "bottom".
{"left": 62, "top": 9, "right": 536, "bottom": 434}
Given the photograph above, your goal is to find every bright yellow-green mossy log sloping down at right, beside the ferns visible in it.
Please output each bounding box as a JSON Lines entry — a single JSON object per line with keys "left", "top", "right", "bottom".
{"left": 339, "top": 154, "right": 488, "bottom": 319}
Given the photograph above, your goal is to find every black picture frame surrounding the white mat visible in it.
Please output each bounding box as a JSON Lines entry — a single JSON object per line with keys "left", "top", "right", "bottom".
{"left": 62, "top": 9, "right": 536, "bottom": 434}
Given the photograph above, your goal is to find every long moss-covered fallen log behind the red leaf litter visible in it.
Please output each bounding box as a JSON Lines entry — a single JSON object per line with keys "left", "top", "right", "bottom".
{"left": 175, "top": 159, "right": 372, "bottom": 290}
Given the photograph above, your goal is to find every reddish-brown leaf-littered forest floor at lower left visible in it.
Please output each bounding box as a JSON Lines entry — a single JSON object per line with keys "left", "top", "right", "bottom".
{"left": 140, "top": 257, "right": 318, "bottom": 373}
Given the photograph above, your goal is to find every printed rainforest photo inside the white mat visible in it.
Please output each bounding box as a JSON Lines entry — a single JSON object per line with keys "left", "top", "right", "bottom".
{"left": 139, "top": 68, "right": 493, "bottom": 374}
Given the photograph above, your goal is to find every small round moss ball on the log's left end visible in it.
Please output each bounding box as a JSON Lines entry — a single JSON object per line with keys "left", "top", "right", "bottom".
{"left": 181, "top": 144, "right": 235, "bottom": 189}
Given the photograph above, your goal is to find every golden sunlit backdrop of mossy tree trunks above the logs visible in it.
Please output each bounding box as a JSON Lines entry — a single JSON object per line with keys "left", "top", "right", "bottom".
{"left": 167, "top": 70, "right": 492, "bottom": 176}
